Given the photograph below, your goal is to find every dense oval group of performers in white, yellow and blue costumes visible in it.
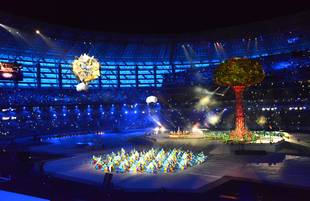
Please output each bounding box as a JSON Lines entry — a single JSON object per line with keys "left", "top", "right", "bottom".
{"left": 91, "top": 148, "right": 208, "bottom": 173}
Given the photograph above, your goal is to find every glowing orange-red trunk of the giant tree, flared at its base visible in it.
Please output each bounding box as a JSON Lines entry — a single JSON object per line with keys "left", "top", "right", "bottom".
{"left": 230, "top": 86, "right": 252, "bottom": 140}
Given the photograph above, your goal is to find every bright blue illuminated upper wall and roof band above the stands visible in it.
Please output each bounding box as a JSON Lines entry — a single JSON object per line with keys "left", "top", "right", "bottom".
{"left": 0, "top": 12, "right": 310, "bottom": 89}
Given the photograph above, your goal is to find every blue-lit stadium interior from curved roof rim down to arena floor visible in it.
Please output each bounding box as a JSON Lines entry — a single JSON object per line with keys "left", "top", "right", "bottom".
{"left": 0, "top": 3, "right": 310, "bottom": 200}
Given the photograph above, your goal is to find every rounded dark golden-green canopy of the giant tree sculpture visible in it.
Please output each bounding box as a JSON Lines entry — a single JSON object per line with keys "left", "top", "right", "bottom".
{"left": 213, "top": 57, "right": 265, "bottom": 86}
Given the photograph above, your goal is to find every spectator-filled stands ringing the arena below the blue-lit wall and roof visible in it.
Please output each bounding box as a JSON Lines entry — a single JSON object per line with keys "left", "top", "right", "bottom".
{"left": 0, "top": 51, "right": 310, "bottom": 139}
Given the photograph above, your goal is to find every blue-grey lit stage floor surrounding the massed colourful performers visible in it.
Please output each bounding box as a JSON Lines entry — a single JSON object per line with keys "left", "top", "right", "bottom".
{"left": 26, "top": 130, "right": 310, "bottom": 193}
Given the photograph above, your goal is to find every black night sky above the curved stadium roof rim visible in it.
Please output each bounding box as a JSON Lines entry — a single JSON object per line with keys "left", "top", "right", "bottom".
{"left": 0, "top": 0, "right": 310, "bottom": 34}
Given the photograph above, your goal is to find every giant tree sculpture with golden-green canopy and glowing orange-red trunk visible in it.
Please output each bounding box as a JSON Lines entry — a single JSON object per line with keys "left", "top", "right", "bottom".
{"left": 213, "top": 57, "right": 265, "bottom": 140}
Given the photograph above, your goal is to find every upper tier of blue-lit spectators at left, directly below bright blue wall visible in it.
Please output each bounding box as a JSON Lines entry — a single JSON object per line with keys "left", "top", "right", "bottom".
{"left": 0, "top": 87, "right": 158, "bottom": 106}
